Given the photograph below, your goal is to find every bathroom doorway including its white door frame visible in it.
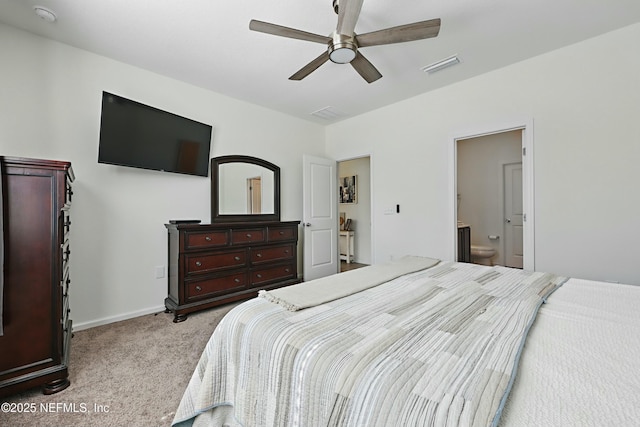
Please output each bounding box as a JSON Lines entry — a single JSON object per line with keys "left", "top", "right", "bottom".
{"left": 450, "top": 122, "right": 535, "bottom": 270}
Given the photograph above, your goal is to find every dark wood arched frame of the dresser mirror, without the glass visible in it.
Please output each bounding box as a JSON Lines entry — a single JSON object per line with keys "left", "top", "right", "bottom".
{"left": 211, "top": 155, "right": 280, "bottom": 223}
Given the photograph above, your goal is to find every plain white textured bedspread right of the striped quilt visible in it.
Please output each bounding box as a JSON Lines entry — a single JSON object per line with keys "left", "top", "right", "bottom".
{"left": 500, "top": 279, "right": 640, "bottom": 427}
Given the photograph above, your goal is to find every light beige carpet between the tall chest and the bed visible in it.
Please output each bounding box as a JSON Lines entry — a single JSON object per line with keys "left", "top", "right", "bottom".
{"left": 0, "top": 303, "right": 237, "bottom": 427}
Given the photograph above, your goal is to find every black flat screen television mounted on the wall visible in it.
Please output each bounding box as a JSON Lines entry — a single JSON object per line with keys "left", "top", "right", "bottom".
{"left": 98, "top": 92, "right": 212, "bottom": 176}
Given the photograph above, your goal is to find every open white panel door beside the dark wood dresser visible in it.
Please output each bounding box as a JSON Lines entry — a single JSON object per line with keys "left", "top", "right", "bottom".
{"left": 302, "top": 155, "right": 339, "bottom": 281}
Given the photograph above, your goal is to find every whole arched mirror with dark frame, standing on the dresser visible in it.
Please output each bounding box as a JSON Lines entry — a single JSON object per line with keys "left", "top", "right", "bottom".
{"left": 211, "top": 155, "right": 280, "bottom": 223}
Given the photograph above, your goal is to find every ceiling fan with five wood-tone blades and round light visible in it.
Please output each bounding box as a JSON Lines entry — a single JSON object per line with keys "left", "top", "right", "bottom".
{"left": 249, "top": 0, "right": 440, "bottom": 83}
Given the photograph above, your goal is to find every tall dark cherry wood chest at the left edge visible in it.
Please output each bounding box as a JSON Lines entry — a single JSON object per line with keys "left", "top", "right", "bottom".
{"left": 0, "top": 157, "right": 74, "bottom": 396}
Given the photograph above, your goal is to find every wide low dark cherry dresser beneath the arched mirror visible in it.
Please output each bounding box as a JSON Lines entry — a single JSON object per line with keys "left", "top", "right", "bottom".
{"left": 165, "top": 221, "right": 300, "bottom": 322}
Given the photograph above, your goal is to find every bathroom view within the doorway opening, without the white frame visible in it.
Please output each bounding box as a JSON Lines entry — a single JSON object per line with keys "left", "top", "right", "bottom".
{"left": 455, "top": 128, "right": 526, "bottom": 268}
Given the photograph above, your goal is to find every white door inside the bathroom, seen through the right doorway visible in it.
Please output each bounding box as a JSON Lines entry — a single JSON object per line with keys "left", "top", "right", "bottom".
{"left": 504, "top": 163, "right": 524, "bottom": 268}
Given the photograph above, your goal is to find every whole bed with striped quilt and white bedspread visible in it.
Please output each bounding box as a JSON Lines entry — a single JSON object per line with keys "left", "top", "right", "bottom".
{"left": 173, "top": 257, "right": 640, "bottom": 427}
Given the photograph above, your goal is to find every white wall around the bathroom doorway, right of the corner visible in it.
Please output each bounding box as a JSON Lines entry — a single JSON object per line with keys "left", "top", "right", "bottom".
{"left": 327, "top": 24, "right": 640, "bottom": 284}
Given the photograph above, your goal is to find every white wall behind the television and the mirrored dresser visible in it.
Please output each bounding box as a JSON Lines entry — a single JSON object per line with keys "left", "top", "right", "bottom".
{"left": 0, "top": 25, "right": 324, "bottom": 329}
